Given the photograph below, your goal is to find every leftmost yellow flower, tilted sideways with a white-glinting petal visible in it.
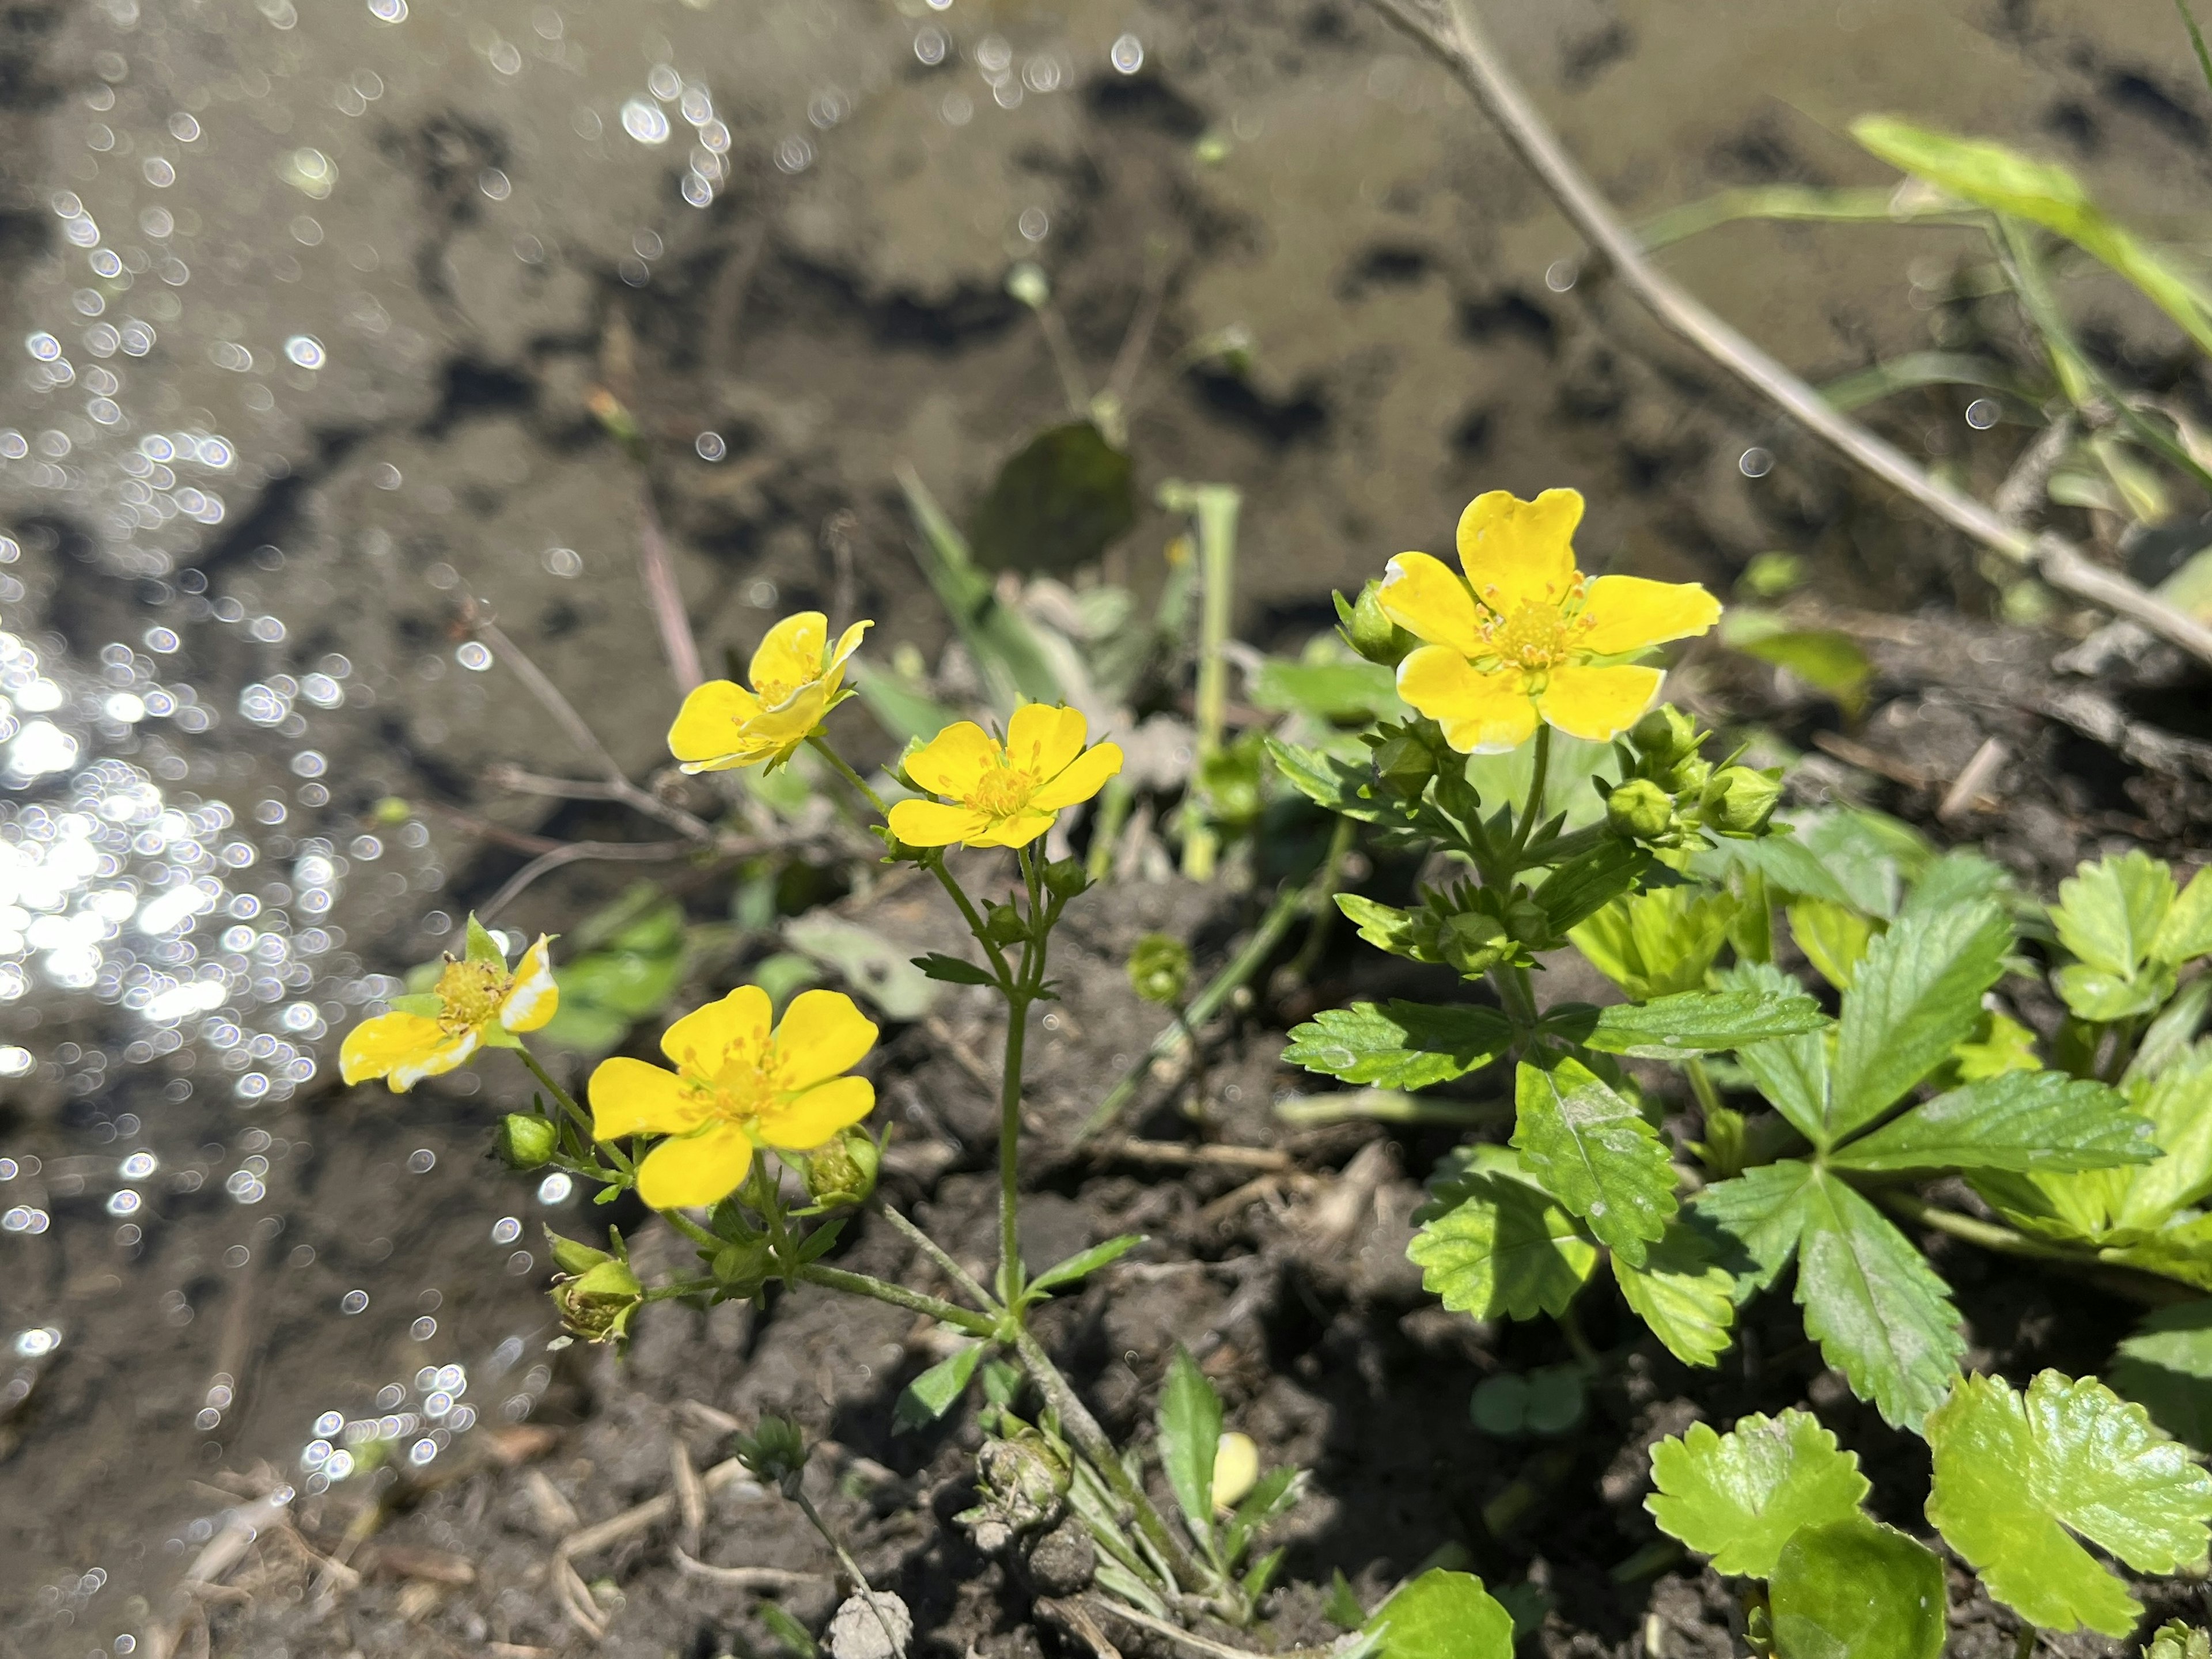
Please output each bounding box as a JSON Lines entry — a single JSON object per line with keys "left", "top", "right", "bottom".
{"left": 339, "top": 916, "right": 560, "bottom": 1093}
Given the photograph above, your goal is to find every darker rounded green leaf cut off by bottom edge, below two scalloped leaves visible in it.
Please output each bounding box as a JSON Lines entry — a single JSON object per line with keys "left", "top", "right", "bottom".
{"left": 1767, "top": 1515, "right": 1949, "bottom": 1659}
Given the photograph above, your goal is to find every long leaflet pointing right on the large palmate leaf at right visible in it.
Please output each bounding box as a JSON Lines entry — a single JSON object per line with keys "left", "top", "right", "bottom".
{"left": 1827, "top": 1071, "right": 2159, "bottom": 1175}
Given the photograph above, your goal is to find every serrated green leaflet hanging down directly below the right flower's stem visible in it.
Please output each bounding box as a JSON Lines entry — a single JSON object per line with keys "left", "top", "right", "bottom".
{"left": 1513, "top": 1055, "right": 1677, "bottom": 1267}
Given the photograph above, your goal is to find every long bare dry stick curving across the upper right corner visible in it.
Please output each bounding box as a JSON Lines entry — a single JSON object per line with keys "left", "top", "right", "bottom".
{"left": 1369, "top": 0, "right": 2212, "bottom": 664}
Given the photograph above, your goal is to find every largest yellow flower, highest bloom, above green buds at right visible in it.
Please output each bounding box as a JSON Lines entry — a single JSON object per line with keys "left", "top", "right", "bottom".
{"left": 1380, "top": 489, "right": 1721, "bottom": 754}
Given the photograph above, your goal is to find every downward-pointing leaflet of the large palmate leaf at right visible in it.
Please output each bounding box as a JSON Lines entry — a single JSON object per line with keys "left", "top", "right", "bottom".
{"left": 1796, "top": 1177, "right": 1967, "bottom": 1433}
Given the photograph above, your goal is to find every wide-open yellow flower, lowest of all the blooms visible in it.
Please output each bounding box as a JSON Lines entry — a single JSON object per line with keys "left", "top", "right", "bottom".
{"left": 590, "top": 984, "right": 876, "bottom": 1210}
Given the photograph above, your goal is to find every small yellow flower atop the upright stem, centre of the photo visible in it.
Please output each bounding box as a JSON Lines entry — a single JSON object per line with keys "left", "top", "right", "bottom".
{"left": 892, "top": 703, "right": 1122, "bottom": 847}
